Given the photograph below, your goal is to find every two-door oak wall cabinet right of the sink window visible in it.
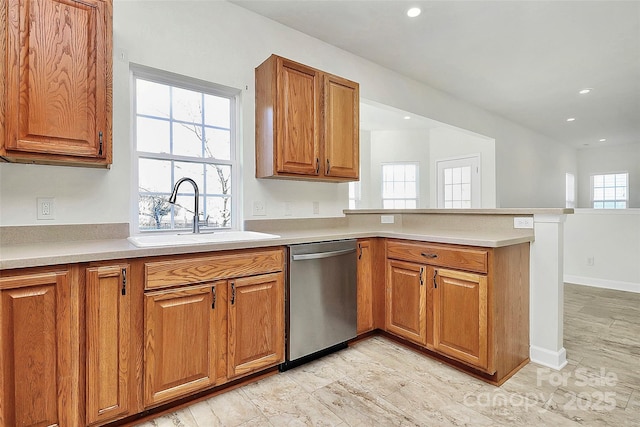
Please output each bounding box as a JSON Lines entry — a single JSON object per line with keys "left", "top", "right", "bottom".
{"left": 256, "top": 55, "right": 360, "bottom": 181}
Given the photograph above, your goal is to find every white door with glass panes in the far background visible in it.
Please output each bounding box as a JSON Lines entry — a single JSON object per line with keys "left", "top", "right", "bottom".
{"left": 436, "top": 154, "right": 481, "bottom": 209}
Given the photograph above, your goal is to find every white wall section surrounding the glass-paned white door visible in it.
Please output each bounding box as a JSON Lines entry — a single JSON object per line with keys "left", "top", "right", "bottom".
{"left": 429, "top": 127, "right": 496, "bottom": 209}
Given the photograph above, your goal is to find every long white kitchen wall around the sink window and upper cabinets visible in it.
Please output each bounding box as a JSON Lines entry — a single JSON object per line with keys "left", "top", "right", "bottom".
{"left": 0, "top": 0, "right": 575, "bottom": 225}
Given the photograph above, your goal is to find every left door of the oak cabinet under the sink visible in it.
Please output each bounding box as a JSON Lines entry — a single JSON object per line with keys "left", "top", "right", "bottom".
{"left": 144, "top": 283, "right": 220, "bottom": 407}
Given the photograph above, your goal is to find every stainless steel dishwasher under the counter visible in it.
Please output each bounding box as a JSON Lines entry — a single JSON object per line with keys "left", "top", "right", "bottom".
{"left": 280, "top": 240, "right": 357, "bottom": 370}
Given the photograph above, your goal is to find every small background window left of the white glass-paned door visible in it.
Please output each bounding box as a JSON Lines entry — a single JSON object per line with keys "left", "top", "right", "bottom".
{"left": 382, "top": 163, "right": 418, "bottom": 209}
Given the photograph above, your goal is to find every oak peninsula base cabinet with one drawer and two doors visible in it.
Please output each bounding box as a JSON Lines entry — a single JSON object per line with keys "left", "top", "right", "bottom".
{"left": 385, "top": 239, "right": 529, "bottom": 384}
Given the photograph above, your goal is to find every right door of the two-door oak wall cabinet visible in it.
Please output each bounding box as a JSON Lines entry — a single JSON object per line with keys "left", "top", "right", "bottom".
{"left": 323, "top": 74, "right": 360, "bottom": 180}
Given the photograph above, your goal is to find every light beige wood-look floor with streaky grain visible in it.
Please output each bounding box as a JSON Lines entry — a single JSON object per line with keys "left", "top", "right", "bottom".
{"left": 140, "top": 285, "right": 640, "bottom": 427}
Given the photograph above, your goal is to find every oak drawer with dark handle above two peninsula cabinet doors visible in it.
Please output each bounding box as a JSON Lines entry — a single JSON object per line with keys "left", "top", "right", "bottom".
{"left": 387, "top": 240, "right": 488, "bottom": 273}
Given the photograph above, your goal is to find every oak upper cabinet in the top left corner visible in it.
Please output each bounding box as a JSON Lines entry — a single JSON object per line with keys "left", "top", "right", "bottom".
{"left": 0, "top": 0, "right": 112, "bottom": 167}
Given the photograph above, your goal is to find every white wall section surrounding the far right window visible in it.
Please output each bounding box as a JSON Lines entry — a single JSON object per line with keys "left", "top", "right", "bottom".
{"left": 576, "top": 143, "right": 640, "bottom": 208}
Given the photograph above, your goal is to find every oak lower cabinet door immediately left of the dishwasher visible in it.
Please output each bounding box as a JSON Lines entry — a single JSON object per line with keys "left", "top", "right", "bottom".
{"left": 228, "top": 273, "right": 284, "bottom": 378}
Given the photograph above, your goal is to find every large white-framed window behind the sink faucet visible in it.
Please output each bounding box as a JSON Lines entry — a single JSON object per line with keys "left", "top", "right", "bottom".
{"left": 133, "top": 68, "right": 239, "bottom": 231}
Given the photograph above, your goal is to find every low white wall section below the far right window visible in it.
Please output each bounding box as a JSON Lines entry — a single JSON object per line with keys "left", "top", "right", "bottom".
{"left": 564, "top": 209, "right": 640, "bottom": 292}
